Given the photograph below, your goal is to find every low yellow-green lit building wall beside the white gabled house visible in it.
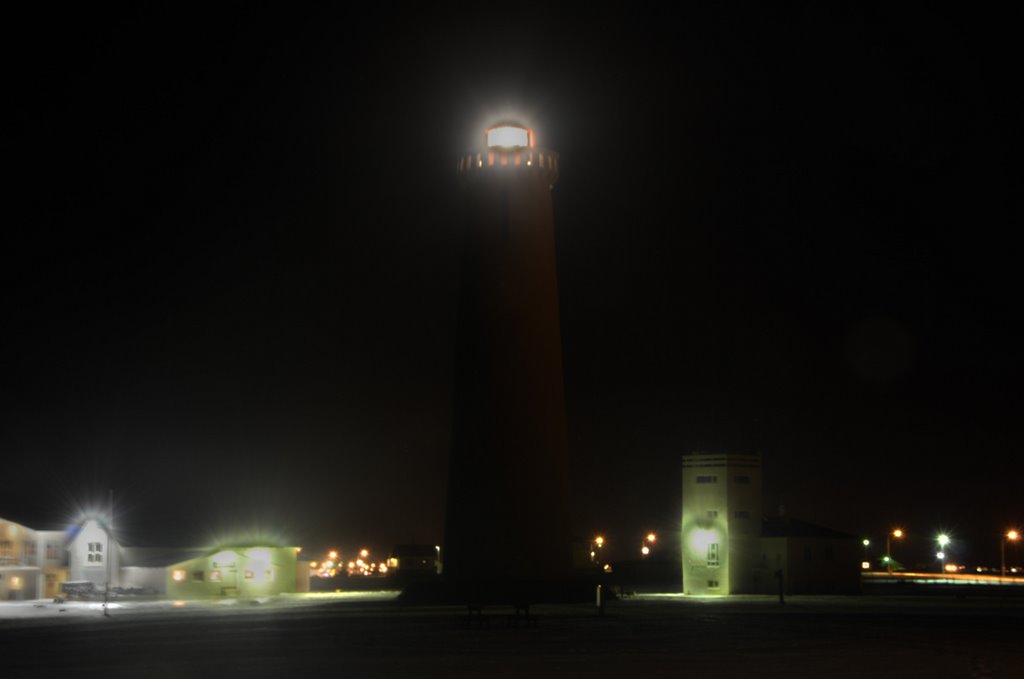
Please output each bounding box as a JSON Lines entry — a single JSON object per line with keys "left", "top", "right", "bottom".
{"left": 165, "top": 547, "right": 299, "bottom": 599}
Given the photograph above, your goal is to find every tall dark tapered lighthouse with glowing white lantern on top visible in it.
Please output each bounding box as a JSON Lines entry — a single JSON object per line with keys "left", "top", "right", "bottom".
{"left": 443, "top": 124, "right": 571, "bottom": 598}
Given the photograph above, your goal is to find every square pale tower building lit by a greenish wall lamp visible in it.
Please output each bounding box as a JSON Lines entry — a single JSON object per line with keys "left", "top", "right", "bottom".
{"left": 682, "top": 453, "right": 761, "bottom": 594}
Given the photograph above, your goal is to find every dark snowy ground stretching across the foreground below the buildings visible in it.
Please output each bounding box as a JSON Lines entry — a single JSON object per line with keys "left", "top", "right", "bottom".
{"left": 0, "top": 595, "right": 1024, "bottom": 679}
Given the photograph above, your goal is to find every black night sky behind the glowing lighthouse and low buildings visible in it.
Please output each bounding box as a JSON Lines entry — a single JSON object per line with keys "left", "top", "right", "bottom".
{"left": 0, "top": 3, "right": 1024, "bottom": 561}
